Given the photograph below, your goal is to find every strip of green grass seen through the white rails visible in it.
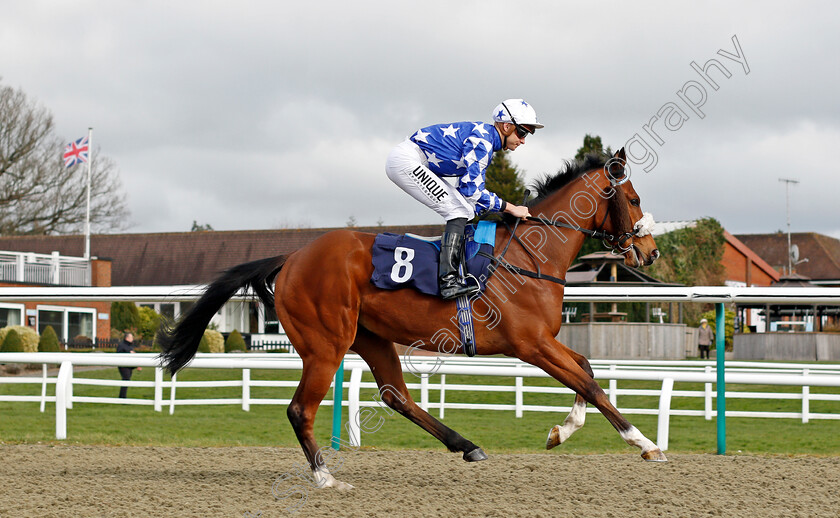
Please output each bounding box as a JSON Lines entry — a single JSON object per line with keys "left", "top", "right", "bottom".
{"left": 0, "top": 368, "right": 840, "bottom": 455}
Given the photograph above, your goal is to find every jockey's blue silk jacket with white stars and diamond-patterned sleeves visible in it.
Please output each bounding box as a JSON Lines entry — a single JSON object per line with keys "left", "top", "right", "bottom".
{"left": 411, "top": 122, "right": 502, "bottom": 215}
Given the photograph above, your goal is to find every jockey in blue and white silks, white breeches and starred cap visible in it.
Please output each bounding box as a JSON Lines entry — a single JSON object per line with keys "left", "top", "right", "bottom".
{"left": 385, "top": 99, "right": 543, "bottom": 299}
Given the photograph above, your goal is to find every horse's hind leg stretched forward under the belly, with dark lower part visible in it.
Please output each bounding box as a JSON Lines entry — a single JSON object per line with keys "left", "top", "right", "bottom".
{"left": 350, "top": 328, "right": 487, "bottom": 462}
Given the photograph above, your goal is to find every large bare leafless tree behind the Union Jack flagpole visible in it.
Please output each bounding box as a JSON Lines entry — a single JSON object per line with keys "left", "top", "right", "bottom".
{"left": 0, "top": 81, "right": 128, "bottom": 235}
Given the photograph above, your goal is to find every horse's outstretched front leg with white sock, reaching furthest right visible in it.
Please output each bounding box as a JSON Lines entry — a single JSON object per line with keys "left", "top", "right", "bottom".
{"left": 520, "top": 337, "right": 668, "bottom": 462}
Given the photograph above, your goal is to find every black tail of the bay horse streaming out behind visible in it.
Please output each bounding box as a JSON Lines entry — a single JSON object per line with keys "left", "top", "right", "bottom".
{"left": 156, "top": 255, "right": 287, "bottom": 374}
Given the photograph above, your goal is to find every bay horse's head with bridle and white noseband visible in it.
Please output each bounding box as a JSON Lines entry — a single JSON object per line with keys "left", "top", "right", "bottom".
{"left": 603, "top": 148, "right": 659, "bottom": 268}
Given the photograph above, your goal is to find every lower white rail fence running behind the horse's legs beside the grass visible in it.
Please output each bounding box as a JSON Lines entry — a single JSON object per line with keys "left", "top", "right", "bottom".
{"left": 0, "top": 353, "right": 840, "bottom": 450}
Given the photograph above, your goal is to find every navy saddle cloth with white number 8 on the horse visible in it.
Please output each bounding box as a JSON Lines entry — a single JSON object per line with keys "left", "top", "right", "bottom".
{"left": 370, "top": 221, "right": 496, "bottom": 297}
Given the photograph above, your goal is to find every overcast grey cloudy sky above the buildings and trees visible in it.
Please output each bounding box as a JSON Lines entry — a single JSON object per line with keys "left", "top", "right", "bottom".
{"left": 0, "top": 0, "right": 840, "bottom": 238}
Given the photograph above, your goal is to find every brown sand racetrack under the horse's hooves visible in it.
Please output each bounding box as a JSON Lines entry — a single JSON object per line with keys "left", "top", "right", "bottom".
{"left": 0, "top": 445, "right": 840, "bottom": 518}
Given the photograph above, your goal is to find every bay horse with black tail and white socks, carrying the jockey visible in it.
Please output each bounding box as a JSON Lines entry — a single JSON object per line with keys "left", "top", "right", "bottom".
{"left": 157, "top": 149, "right": 666, "bottom": 489}
